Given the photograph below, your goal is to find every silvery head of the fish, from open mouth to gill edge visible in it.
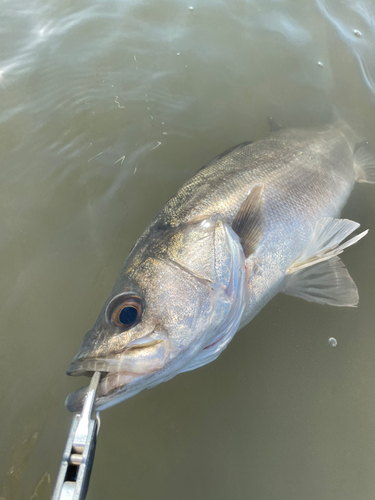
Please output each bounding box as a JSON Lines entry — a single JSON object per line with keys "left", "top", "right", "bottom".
{"left": 66, "top": 219, "right": 245, "bottom": 411}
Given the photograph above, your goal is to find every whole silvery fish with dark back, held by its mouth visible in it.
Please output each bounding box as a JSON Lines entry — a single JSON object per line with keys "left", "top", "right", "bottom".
{"left": 66, "top": 120, "right": 375, "bottom": 412}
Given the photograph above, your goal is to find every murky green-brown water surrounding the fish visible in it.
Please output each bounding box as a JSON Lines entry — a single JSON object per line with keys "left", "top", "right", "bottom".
{"left": 0, "top": 0, "right": 375, "bottom": 500}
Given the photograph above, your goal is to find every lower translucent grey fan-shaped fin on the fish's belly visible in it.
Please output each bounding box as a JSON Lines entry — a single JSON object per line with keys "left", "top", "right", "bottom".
{"left": 283, "top": 257, "right": 358, "bottom": 307}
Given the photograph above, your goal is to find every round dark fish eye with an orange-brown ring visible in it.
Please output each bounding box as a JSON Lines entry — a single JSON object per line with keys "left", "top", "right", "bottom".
{"left": 106, "top": 294, "right": 143, "bottom": 330}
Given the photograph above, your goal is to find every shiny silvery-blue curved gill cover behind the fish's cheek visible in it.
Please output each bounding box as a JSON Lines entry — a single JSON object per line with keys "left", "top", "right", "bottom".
{"left": 173, "top": 219, "right": 247, "bottom": 373}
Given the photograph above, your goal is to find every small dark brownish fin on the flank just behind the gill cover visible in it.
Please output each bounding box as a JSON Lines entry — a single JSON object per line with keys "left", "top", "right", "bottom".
{"left": 232, "top": 184, "right": 264, "bottom": 259}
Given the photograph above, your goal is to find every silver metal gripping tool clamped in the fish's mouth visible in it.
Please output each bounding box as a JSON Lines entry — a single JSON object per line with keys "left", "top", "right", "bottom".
{"left": 52, "top": 372, "right": 101, "bottom": 500}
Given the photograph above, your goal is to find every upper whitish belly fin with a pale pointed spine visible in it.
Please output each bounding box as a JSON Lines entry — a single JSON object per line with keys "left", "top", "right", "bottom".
{"left": 288, "top": 217, "right": 368, "bottom": 274}
